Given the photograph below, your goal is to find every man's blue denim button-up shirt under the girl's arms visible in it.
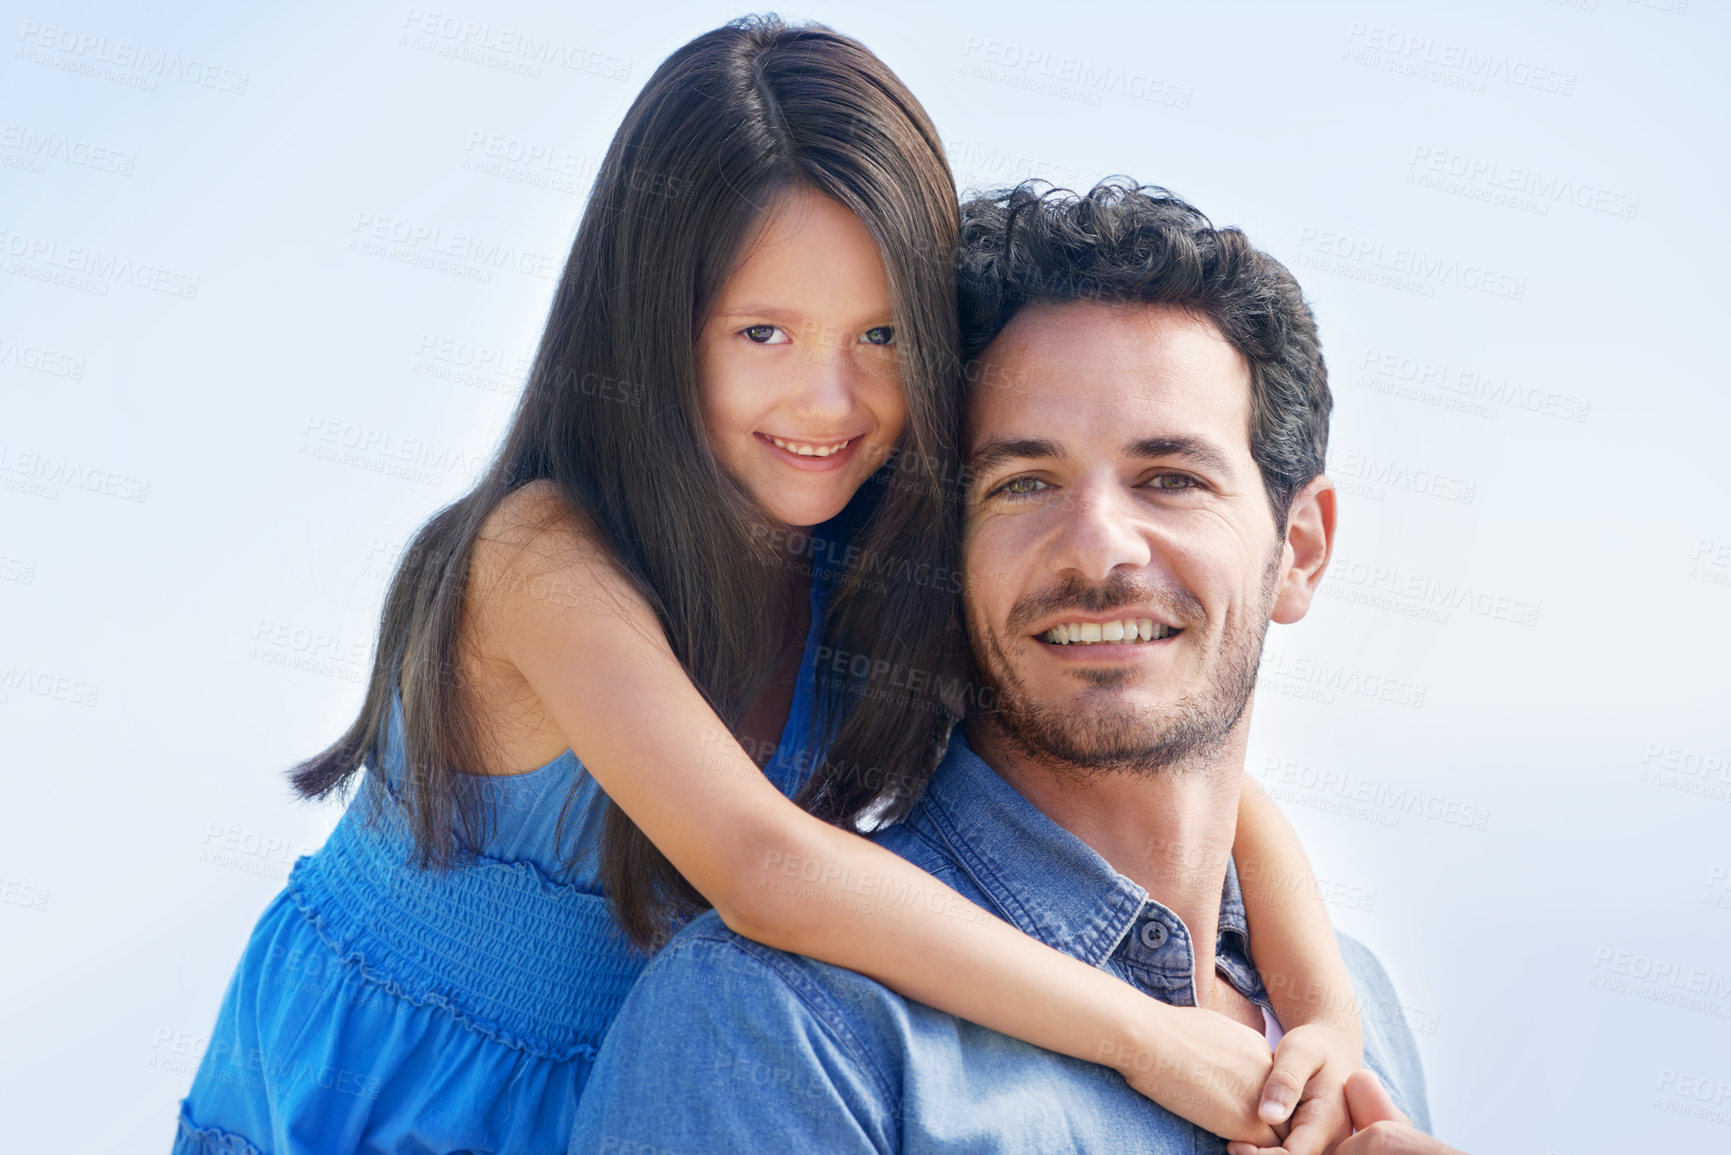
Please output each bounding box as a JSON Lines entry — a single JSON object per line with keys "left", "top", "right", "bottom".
{"left": 569, "top": 731, "right": 1430, "bottom": 1155}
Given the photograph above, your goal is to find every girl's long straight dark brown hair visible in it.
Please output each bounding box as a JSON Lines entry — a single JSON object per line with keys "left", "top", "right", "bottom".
{"left": 291, "top": 17, "right": 962, "bottom": 945}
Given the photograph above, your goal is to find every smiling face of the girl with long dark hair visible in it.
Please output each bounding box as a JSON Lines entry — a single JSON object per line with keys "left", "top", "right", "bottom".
{"left": 698, "top": 189, "right": 907, "bottom": 528}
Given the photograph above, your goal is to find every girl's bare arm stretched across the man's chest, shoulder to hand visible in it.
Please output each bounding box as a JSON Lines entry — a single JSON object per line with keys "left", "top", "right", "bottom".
{"left": 471, "top": 481, "right": 1274, "bottom": 1143}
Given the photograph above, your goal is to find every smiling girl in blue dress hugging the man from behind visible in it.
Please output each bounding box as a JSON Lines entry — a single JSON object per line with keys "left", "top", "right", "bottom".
{"left": 175, "top": 19, "right": 1359, "bottom": 1155}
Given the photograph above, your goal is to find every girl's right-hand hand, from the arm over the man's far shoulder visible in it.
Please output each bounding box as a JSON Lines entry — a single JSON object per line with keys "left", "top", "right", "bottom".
{"left": 1226, "top": 1023, "right": 1364, "bottom": 1155}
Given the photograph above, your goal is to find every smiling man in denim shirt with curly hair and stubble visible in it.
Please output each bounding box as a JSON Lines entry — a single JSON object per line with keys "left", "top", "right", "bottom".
{"left": 571, "top": 185, "right": 1449, "bottom": 1155}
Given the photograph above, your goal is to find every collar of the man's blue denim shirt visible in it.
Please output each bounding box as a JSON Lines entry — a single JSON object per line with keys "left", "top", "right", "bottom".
{"left": 907, "top": 726, "right": 1250, "bottom": 966}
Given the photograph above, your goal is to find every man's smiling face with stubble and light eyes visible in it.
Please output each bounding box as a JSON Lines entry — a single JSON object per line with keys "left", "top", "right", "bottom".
{"left": 964, "top": 303, "right": 1301, "bottom": 771}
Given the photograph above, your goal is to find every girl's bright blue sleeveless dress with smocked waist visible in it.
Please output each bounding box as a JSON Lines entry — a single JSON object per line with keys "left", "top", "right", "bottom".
{"left": 173, "top": 529, "right": 838, "bottom": 1155}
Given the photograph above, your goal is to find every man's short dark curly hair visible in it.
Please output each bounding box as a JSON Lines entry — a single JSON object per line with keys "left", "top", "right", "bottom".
{"left": 957, "top": 178, "right": 1335, "bottom": 535}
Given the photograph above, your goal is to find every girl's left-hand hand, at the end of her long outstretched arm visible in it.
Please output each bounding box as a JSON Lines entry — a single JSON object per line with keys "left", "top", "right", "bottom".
{"left": 1113, "top": 1003, "right": 1286, "bottom": 1150}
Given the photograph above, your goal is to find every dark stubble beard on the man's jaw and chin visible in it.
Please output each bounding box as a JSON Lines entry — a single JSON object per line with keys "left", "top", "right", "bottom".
{"left": 968, "top": 549, "right": 1283, "bottom": 774}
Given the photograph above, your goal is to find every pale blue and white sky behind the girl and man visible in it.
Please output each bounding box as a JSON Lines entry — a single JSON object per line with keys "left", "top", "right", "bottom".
{"left": 0, "top": 0, "right": 1731, "bottom": 1155}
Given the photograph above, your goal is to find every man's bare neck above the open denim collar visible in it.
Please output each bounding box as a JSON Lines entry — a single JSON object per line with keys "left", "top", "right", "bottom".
{"left": 968, "top": 719, "right": 1248, "bottom": 1006}
